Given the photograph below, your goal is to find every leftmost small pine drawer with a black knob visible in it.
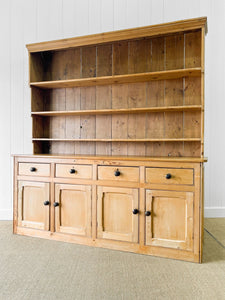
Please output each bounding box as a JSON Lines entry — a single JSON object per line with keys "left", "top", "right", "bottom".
{"left": 19, "top": 163, "right": 50, "bottom": 176}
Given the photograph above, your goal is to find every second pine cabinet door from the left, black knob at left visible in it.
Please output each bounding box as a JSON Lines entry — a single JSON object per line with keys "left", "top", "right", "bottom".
{"left": 55, "top": 184, "right": 91, "bottom": 236}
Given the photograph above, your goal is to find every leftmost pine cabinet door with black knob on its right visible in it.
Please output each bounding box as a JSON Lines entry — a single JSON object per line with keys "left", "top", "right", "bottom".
{"left": 18, "top": 181, "right": 49, "bottom": 230}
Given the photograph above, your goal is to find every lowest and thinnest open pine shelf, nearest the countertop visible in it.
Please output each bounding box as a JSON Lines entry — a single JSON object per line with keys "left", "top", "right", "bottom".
{"left": 32, "top": 138, "right": 201, "bottom": 143}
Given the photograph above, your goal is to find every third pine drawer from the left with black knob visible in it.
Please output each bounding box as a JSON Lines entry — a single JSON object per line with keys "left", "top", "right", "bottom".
{"left": 98, "top": 166, "right": 139, "bottom": 182}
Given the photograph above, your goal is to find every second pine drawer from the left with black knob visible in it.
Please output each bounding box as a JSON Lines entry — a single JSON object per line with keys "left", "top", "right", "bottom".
{"left": 55, "top": 164, "right": 92, "bottom": 179}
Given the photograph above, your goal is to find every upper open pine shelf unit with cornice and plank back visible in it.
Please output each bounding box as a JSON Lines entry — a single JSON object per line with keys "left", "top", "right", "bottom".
{"left": 27, "top": 18, "right": 206, "bottom": 157}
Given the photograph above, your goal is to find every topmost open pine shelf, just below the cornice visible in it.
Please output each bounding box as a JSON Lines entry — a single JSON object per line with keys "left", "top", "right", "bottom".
{"left": 30, "top": 68, "right": 201, "bottom": 89}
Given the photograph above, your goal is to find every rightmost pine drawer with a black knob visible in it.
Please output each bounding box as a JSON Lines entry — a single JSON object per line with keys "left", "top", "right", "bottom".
{"left": 146, "top": 168, "right": 194, "bottom": 185}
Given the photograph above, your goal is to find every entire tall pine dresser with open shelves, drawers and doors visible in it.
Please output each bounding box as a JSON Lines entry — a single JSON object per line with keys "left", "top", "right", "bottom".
{"left": 13, "top": 18, "right": 207, "bottom": 262}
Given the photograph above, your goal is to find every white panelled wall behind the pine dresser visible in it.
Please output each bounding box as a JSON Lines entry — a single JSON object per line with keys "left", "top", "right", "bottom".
{"left": 0, "top": 0, "right": 225, "bottom": 219}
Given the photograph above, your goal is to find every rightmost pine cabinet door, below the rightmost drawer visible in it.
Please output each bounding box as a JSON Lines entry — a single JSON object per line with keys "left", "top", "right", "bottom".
{"left": 145, "top": 190, "right": 193, "bottom": 250}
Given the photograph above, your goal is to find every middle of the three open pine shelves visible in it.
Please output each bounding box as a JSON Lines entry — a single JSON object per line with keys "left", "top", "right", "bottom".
{"left": 31, "top": 105, "right": 202, "bottom": 117}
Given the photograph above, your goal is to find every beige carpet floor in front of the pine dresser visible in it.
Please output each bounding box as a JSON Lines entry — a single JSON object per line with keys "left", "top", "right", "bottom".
{"left": 0, "top": 219, "right": 225, "bottom": 300}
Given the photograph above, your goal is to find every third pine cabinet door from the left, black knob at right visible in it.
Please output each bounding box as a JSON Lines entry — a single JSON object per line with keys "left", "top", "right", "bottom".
{"left": 97, "top": 187, "right": 139, "bottom": 243}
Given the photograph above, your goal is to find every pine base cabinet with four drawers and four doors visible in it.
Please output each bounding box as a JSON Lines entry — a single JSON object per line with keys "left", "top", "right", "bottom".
{"left": 14, "top": 157, "right": 203, "bottom": 262}
